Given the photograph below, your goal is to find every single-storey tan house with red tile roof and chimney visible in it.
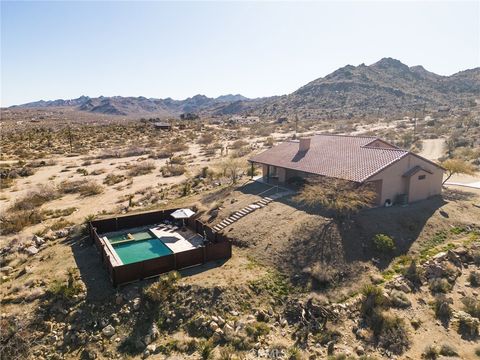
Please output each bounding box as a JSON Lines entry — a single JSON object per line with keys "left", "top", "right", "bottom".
{"left": 249, "top": 135, "right": 444, "bottom": 206}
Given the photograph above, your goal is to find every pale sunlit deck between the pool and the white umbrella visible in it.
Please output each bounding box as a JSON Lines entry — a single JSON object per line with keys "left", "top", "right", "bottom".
{"left": 149, "top": 225, "right": 203, "bottom": 253}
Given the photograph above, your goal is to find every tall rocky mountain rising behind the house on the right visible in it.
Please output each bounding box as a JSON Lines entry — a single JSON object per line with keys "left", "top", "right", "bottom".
{"left": 232, "top": 58, "right": 480, "bottom": 118}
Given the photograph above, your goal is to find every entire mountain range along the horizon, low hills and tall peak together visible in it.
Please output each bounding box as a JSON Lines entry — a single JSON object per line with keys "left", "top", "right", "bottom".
{"left": 9, "top": 58, "right": 480, "bottom": 118}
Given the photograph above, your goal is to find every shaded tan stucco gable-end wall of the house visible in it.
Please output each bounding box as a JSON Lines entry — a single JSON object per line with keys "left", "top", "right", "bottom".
{"left": 368, "top": 154, "right": 443, "bottom": 204}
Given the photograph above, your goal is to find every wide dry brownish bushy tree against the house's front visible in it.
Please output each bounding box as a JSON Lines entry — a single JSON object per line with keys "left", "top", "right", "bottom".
{"left": 294, "top": 178, "right": 377, "bottom": 217}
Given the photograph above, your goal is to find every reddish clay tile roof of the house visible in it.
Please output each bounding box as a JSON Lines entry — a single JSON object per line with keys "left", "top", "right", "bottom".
{"left": 249, "top": 135, "right": 409, "bottom": 182}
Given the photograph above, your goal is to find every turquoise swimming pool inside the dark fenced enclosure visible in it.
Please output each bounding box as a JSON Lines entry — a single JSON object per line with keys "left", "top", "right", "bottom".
{"left": 112, "top": 239, "right": 173, "bottom": 264}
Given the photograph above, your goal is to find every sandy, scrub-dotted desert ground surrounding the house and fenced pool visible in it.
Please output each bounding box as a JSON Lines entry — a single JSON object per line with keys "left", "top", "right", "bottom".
{"left": 0, "top": 110, "right": 480, "bottom": 359}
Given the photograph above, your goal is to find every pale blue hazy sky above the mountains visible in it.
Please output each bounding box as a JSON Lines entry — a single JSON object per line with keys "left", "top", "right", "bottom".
{"left": 1, "top": 1, "right": 480, "bottom": 106}
